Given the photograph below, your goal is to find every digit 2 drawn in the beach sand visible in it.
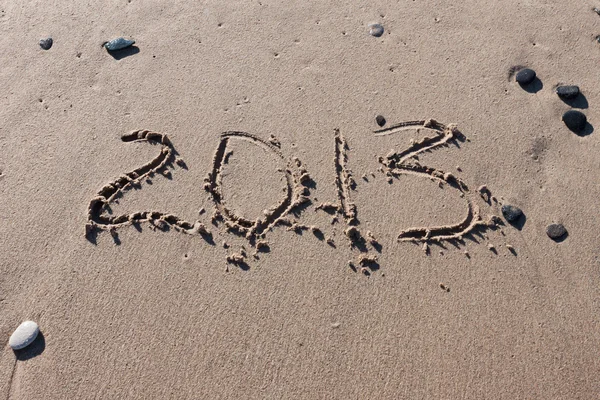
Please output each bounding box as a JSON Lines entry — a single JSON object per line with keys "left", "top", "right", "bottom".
{"left": 85, "top": 130, "right": 210, "bottom": 240}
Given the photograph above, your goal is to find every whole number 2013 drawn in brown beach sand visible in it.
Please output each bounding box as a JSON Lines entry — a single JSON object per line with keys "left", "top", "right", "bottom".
{"left": 85, "top": 120, "right": 499, "bottom": 273}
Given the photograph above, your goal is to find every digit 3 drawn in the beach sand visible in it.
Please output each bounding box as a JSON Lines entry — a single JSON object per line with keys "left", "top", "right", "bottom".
{"left": 375, "top": 119, "right": 499, "bottom": 242}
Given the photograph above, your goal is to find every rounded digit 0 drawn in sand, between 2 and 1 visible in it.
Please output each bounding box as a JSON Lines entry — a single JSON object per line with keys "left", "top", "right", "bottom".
{"left": 204, "top": 132, "right": 310, "bottom": 244}
